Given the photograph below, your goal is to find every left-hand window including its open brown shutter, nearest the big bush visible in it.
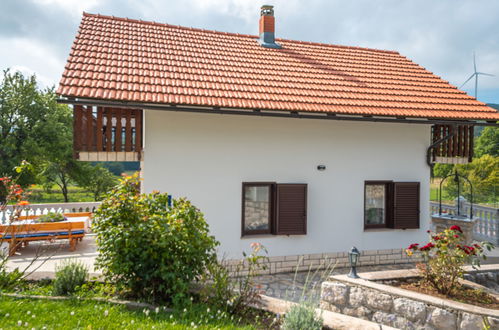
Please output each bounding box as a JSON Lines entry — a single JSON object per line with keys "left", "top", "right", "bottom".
{"left": 242, "top": 182, "right": 307, "bottom": 236}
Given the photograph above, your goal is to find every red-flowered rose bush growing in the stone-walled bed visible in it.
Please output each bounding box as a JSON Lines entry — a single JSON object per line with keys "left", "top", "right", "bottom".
{"left": 406, "top": 225, "right": 494, "bottom": 295}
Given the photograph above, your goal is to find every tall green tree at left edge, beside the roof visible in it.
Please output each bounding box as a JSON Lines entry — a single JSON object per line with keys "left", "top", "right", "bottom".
{"left": 0, "top": 70, "right": 87, "bottom": 202}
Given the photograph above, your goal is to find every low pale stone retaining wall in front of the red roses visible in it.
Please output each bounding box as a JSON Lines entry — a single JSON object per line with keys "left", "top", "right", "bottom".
{"left": 321, "top": 272, "right": 499, "bottom": 330}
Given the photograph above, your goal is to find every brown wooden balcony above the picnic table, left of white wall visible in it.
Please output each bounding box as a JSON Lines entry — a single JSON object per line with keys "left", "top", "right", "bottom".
{"left": 73, "top": 105, "right": 142, "bottom": 161}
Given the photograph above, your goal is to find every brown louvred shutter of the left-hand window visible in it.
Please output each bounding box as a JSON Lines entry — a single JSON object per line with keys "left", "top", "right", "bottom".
{"left": 275, "top": 184, "right": 307, "bottom": 235}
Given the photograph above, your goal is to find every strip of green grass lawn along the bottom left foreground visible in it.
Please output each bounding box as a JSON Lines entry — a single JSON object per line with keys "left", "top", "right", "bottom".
{"left": 0, "top": 297, "right": 255, "bottom": 329}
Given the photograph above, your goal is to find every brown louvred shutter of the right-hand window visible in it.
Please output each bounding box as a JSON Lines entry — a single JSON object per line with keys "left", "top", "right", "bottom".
{"left": 393, "top": 182, "right": 419, "bottom": 229}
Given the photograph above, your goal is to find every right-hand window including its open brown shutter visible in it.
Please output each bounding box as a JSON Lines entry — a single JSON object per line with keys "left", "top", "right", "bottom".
{"left": 364, "top": 181, "right": 419, "bottom": 229}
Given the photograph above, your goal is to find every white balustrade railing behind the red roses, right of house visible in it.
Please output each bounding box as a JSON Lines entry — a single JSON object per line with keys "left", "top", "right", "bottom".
{"left": 430, "top": 202, "right": 499, "bottom": 245}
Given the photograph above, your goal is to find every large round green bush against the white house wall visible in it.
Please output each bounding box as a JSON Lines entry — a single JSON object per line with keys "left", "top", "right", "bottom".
{"left": 93, "top": 175, "right": 218, "bottom": 303}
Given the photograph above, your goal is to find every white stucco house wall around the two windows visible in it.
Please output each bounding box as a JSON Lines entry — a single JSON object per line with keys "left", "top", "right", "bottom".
{"left": 143, "top": 110, "right": 430, "bottom": 258}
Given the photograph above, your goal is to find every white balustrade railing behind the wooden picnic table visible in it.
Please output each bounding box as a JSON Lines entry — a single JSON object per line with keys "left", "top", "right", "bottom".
{"left": 0, "top": 202, "right": 101, "bottom": 224}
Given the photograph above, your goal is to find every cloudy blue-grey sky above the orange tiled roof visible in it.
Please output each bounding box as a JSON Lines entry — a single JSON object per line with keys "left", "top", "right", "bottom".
{"left": 0, "top": 0, "right": 499, "bottom": 103}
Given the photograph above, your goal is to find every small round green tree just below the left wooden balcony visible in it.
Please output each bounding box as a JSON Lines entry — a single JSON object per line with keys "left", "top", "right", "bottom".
{"left": 79, "top": 165, "right": 118, "bottom": 201}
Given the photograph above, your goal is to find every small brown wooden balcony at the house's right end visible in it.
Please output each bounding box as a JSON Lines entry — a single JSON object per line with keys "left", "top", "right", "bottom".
{"left": 431, "top": 125, "right": 474, "bottom": 164}
